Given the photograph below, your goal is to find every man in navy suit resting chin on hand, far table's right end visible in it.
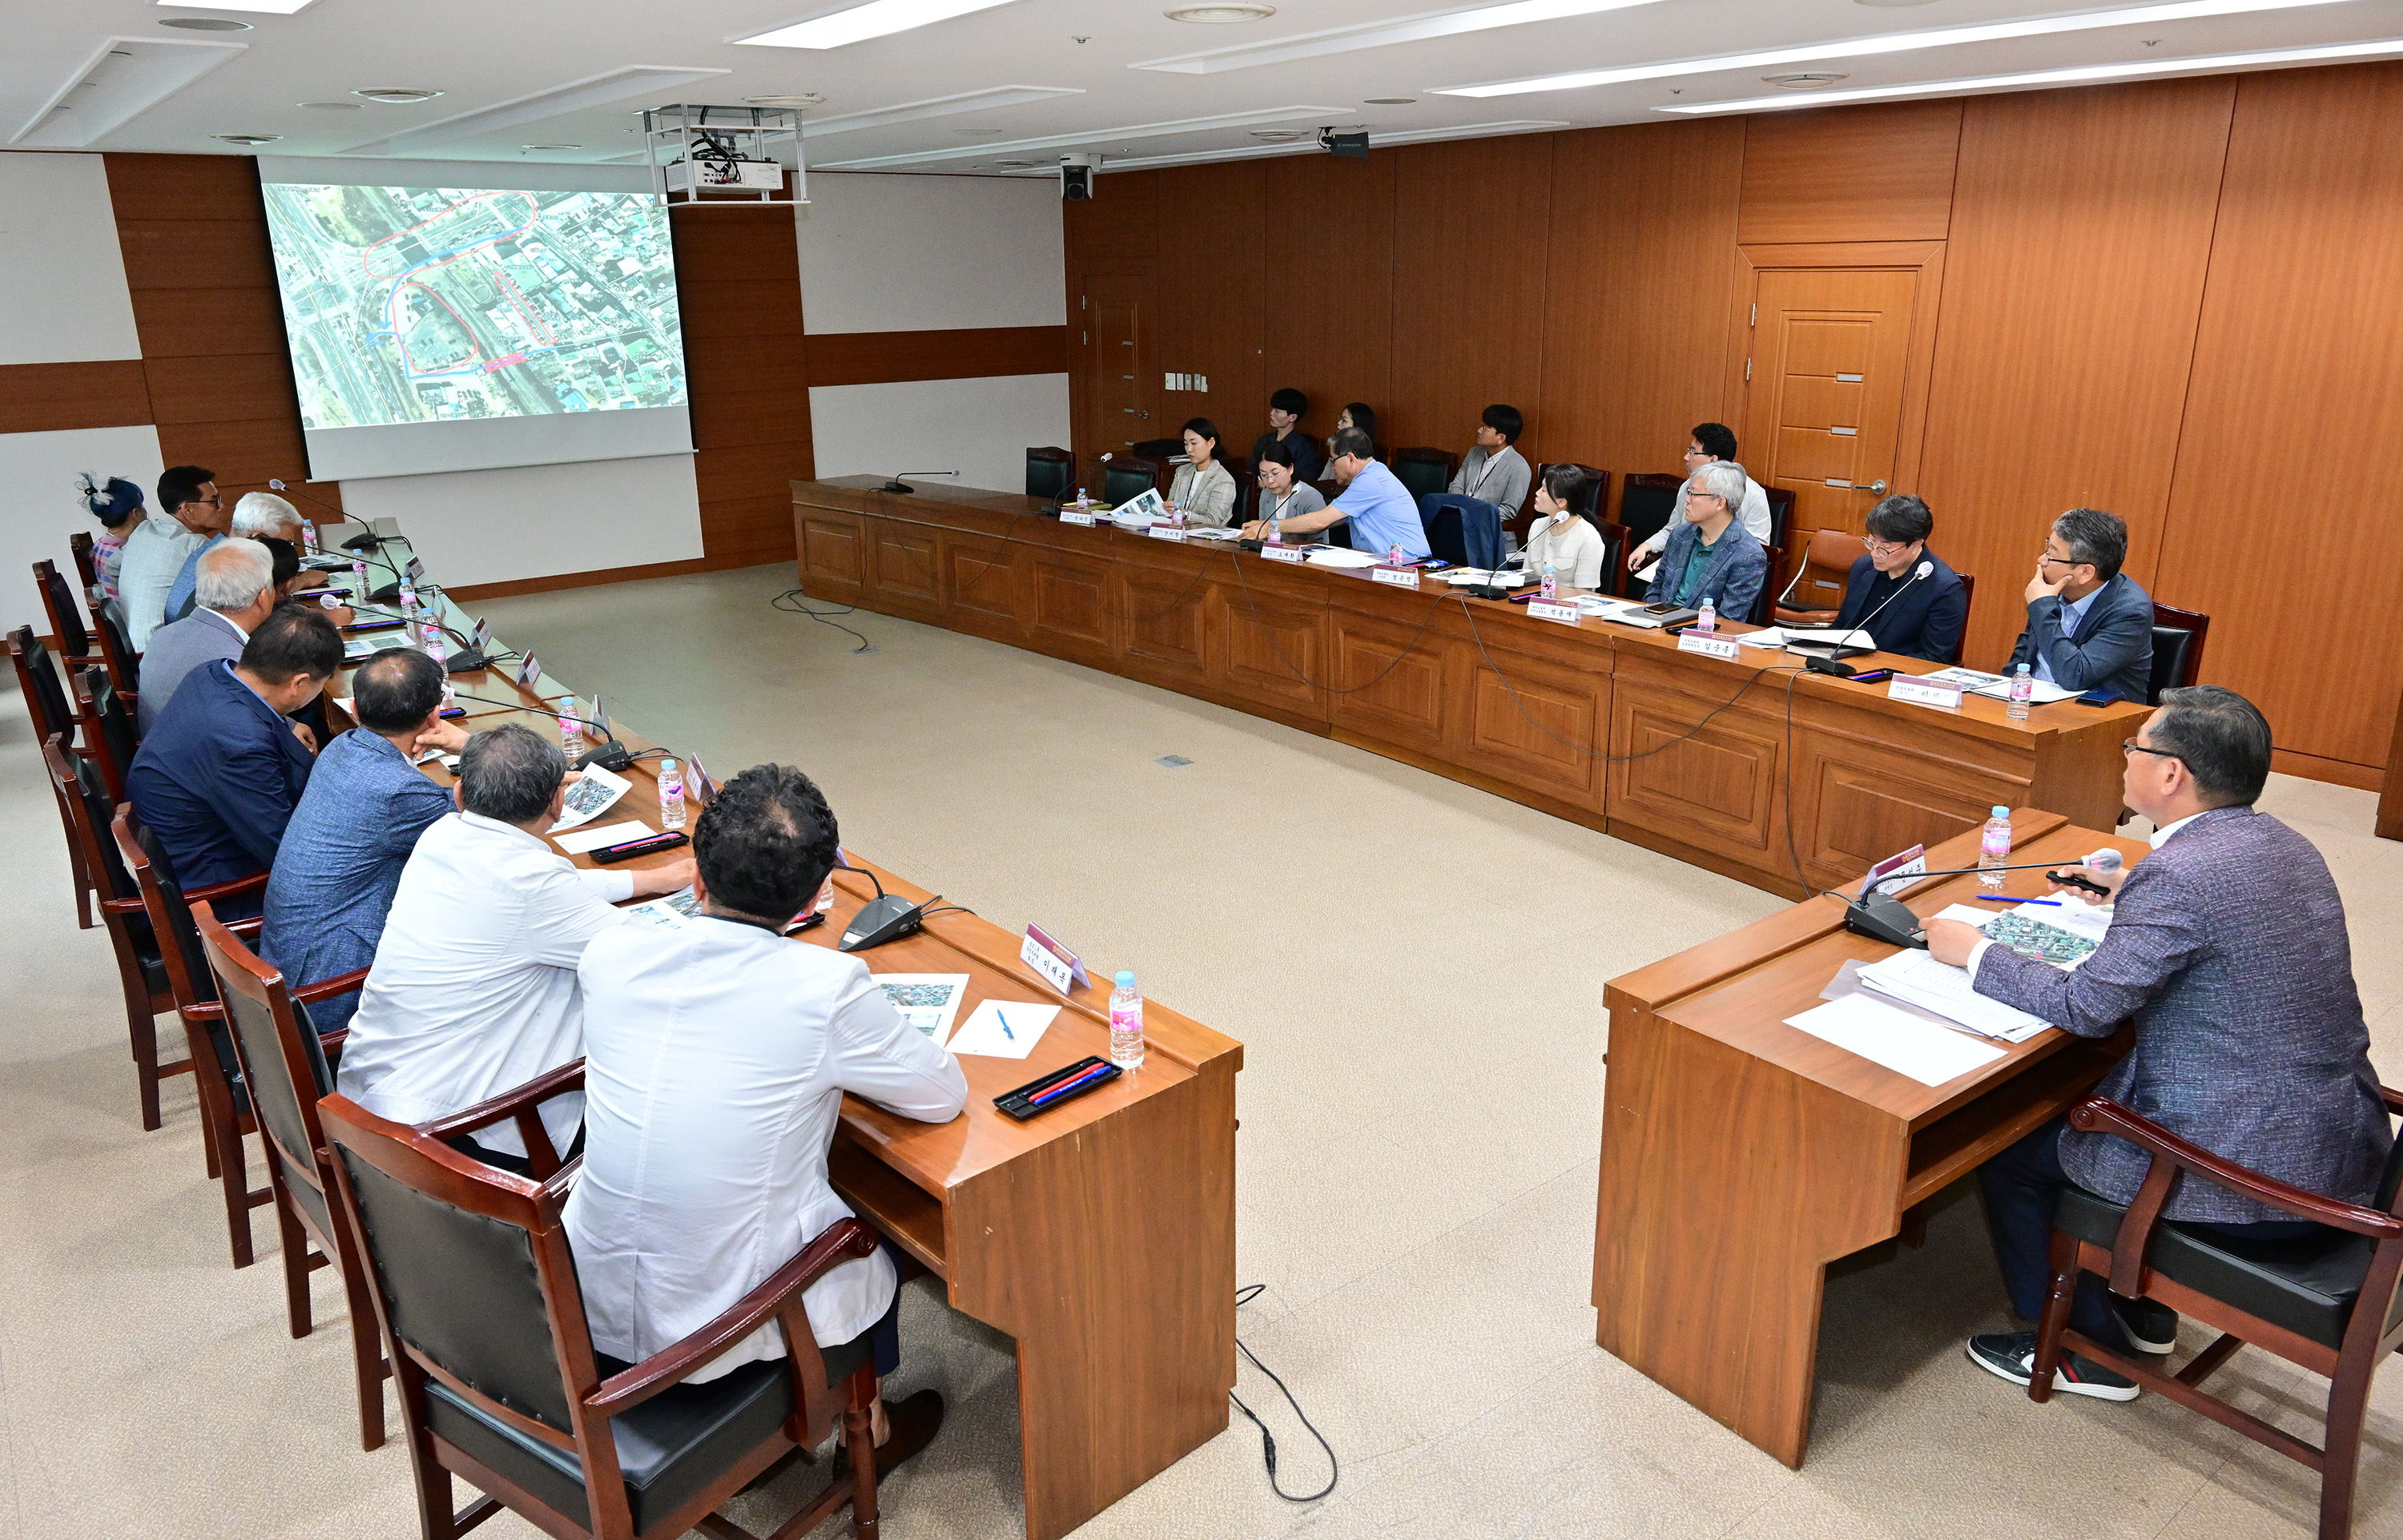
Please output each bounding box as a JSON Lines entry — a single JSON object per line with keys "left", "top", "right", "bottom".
{"left": 2007, "top": 507, "right": 2153, "bottom": 702}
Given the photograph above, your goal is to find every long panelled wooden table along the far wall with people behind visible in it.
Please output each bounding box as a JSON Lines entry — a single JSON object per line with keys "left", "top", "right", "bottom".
{"left": 793, "top": 476, "right": 2146, "bottom": 899}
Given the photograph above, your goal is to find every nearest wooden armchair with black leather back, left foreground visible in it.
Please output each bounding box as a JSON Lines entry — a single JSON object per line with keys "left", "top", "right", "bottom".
{"left": 320, "top": 1086, "right": 904, "bottom": 1540}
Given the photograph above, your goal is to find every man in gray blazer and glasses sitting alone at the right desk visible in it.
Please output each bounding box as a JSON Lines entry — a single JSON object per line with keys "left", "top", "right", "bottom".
{"left": 1927, "top": 685, "right": 2393, "bottom": 1401}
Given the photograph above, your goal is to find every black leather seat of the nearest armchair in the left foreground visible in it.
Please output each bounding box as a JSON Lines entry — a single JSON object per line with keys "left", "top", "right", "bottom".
{"left": 425, "top": 1357, "right": 793, "bottom": 1533}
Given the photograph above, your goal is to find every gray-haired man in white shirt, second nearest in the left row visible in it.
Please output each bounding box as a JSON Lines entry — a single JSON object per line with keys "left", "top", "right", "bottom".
{"left": 334, "top": 723, "right": 692, "bottom": 1168}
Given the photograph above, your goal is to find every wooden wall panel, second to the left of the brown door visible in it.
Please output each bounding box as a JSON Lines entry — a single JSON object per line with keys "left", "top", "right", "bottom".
{"left": 1394, "top": 135, "right": 1552, "bottom": 461}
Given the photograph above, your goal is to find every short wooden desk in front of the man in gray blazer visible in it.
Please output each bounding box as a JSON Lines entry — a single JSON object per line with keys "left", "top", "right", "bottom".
{"left": 1593, "top": 810, "right": 2148, "bottom": 1466}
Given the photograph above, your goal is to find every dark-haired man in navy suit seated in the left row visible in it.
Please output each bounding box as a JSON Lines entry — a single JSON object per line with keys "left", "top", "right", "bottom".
{"left": 125, "top": 605, "right": 341, "bottom": 918}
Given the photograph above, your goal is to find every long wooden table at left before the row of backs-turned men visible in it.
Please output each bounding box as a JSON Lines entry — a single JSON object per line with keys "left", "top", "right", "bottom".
{"left": 327, "top": 526, "right": 1242, "bottom": 1540}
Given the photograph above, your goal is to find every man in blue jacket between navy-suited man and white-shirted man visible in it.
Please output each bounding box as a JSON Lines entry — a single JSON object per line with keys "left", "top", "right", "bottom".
{"left": 260, "top": 646, "right": 466, "bottom": 1033}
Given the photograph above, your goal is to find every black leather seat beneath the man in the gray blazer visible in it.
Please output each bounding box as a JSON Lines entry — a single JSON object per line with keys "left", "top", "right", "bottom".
{"left": 2052, "top": 1177, "right": 2403, "bottom": 1348}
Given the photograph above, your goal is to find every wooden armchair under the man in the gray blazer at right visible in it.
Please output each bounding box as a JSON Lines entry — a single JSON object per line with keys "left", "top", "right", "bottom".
{"left": 2028, "top": 1088, "right": 2403, "bottom": 1540}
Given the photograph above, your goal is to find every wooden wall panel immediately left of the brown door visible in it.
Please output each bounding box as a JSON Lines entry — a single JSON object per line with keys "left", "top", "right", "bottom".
{"left": 1540, "top": 118, "right": 1745, "bottom": 493}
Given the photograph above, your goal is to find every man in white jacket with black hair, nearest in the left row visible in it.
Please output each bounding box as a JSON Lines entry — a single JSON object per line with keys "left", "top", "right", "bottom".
{"left": 562, "top": 764, "right": 968, "bottom": 1470}
